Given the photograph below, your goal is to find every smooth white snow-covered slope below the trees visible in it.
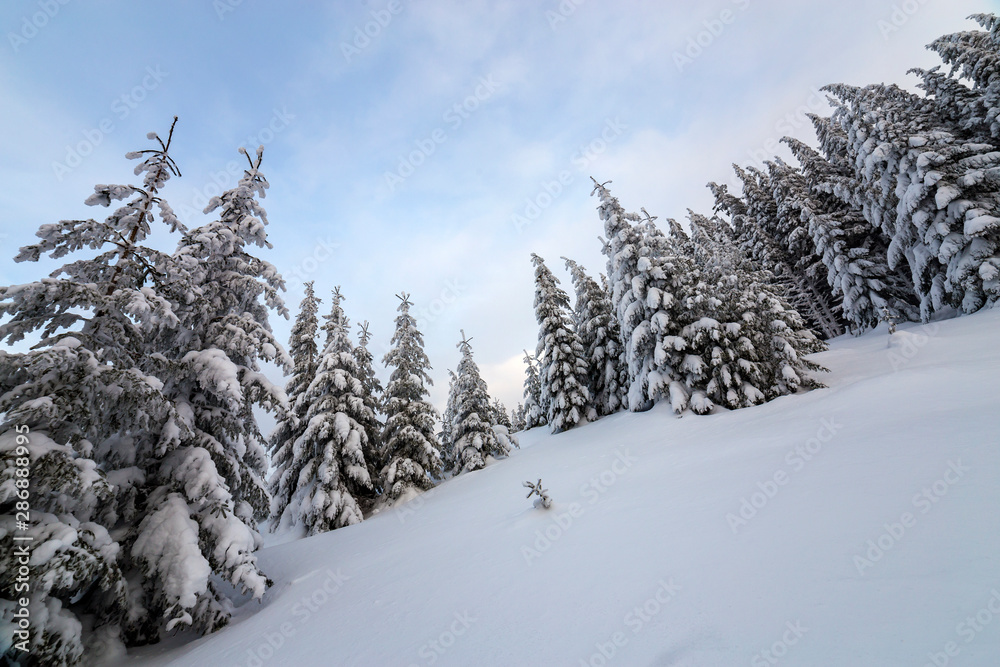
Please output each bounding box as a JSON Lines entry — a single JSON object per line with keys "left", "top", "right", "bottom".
{"left": 125, "top": 310, "right": 1000, "bottom": 667}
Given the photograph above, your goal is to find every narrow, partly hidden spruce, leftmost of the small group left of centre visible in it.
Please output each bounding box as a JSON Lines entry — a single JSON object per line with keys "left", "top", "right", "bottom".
{"left": 268, "top": 281, "right": 320, "bottom": 517}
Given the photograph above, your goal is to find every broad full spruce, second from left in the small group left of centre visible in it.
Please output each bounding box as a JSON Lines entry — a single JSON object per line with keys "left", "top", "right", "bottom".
{"left": 279, "top": 288, "right": 372, "bottom": 535}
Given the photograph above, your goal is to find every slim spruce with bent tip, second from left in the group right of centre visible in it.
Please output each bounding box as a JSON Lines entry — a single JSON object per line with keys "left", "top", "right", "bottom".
{"left": 563, "top": 257, "right": 628, "bottom": 416}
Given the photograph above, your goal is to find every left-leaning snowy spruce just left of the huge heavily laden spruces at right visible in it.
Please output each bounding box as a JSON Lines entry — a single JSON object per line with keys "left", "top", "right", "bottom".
{"left": 774, "top": 138, "right": 917, "bottom": 334}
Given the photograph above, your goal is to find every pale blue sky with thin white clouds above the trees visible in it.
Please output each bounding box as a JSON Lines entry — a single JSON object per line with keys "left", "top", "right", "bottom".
{"left": 0, "top": 0, "right": 1000, "bottom": 409}
